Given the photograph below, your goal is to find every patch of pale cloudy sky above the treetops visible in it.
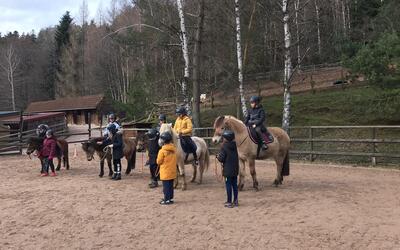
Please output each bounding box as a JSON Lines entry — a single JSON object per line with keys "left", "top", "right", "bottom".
{"left": 0, "top": 0, "right": 110, "bottom": 34}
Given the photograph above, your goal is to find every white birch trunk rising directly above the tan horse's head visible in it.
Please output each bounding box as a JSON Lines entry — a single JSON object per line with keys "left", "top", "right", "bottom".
{"left": 235, "top": 0, "right": 247, "bottom": 117}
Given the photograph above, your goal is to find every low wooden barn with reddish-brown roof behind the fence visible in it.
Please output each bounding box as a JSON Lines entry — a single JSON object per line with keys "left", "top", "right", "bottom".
{"left": 26, "top": 95, "right": 110, "bottom": 125}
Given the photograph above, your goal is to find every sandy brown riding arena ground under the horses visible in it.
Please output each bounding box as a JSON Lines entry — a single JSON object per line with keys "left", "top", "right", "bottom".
{"left": 0, "top": 146, "right": 400, "bottom": 249}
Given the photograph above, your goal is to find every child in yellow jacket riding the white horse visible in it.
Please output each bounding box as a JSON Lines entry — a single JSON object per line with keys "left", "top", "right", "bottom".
{"left": 174, "top": 107, "right": 199, "bottom": 166}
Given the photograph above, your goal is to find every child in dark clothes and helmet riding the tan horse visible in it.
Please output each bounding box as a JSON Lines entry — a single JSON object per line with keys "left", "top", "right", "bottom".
{"left": 244, "top": 96, "right": 268, "bottom": 150}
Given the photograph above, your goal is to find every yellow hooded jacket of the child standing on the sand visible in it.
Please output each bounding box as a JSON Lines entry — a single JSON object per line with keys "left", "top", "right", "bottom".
{"left": 157, "top": 143, "right": 176, "bottom": 181}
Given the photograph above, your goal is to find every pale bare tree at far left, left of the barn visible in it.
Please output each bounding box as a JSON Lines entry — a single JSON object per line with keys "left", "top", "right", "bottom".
{"left": 0, "top": 45, "right": 20, "bottom": 111}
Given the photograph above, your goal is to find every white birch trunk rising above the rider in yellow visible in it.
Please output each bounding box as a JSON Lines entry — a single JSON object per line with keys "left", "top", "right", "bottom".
{"left": 176, "top": 0, "right": 191, "bottom": 114}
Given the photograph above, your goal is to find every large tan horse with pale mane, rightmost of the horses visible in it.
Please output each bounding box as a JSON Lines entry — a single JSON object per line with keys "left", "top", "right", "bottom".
{"left": 212, "top": 116, "right": 290, "bottom": 190}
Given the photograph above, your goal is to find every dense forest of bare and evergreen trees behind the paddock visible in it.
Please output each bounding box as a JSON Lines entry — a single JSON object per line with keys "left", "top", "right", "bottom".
{"left": 0, "top": 0, "right": 400, "bottom": 126}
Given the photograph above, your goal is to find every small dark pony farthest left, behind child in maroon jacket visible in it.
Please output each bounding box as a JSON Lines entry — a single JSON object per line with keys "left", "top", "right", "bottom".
{"left": 26, "top": 137, "right": 69, "bottom": 171}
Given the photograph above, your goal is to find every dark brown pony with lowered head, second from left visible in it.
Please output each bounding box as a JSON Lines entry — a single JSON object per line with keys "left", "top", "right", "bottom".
{"left": 82, "top": 137, "right": 136, "bottom": 177}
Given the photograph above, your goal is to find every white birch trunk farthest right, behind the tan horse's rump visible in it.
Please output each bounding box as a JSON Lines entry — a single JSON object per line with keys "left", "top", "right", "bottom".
{"left": 282, "top": 0, "right": 292, "bottom": 132}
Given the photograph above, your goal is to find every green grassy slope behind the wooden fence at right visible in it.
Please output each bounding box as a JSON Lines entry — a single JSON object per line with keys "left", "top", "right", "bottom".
{"left": 201, "top": 86, "right": 400, "bottom": 126}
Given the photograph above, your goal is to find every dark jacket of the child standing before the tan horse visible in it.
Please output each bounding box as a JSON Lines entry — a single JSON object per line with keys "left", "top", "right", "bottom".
{"left": 217, "top": 141, "right": 239, "bottom": 177}
